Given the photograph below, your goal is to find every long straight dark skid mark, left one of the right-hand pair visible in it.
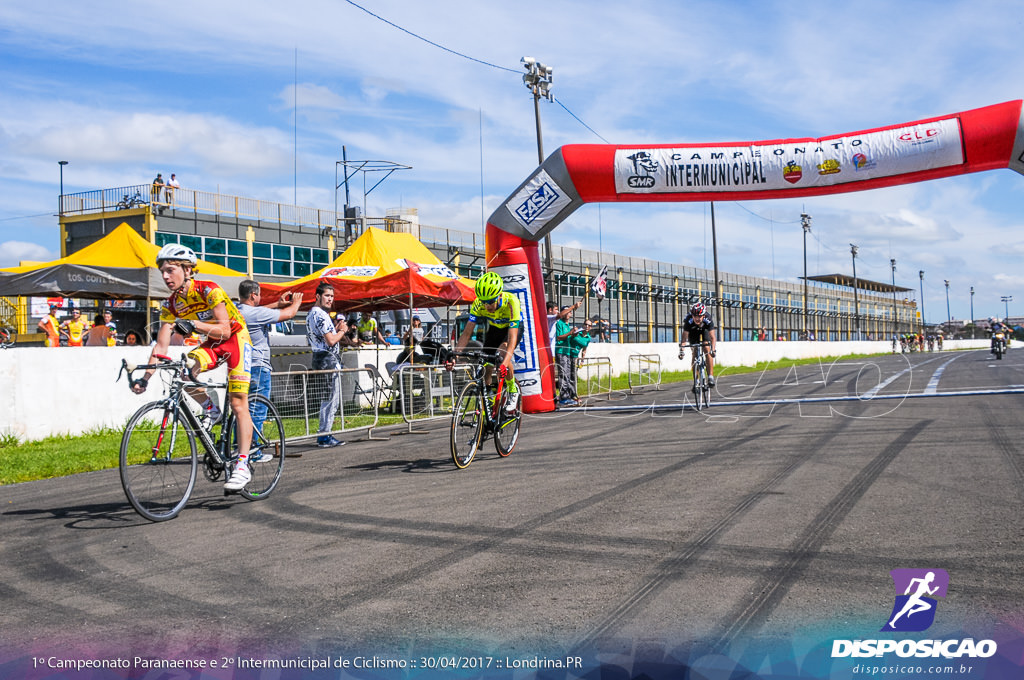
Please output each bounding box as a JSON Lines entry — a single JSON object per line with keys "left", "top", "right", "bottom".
{"left": 572, "top": 419, "right": 851, "bottom": 650}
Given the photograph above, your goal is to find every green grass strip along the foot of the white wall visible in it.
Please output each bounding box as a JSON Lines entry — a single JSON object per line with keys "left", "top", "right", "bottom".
{"left": 0, "top": 354, "right": 892, "bottom": 485}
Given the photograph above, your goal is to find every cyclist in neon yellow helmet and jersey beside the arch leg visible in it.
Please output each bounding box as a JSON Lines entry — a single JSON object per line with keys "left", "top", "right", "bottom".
{"left": 450, "top": 271, "right": 522, "bottom": 413}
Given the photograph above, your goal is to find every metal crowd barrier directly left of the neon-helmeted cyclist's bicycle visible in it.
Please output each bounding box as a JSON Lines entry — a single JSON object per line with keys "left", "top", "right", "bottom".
{"left": 392, "top": 364, "right": 471, "bottom": 434}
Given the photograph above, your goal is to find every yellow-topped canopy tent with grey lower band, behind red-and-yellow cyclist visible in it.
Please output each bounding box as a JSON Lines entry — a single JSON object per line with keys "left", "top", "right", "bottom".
{"left": 0, "top": 222, "right": 246, "bottom": 300}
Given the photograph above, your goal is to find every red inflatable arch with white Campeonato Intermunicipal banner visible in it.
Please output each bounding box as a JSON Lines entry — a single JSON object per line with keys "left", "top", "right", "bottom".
{"left": 486, "top": 99, "right": 1024, "bottom": 413}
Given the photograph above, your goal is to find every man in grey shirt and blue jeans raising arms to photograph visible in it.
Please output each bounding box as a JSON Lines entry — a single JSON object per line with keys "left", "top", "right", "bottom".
{"left": 239, "top": 281, "right": 302, "bottom": 462}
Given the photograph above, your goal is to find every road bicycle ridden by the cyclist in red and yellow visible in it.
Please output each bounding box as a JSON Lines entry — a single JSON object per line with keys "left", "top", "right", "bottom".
{"left": 118, "top": 354, "right": 285, "bottom": 521}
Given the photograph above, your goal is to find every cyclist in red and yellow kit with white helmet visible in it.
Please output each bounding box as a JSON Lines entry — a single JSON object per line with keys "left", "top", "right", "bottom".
{"left": 133, "top": 244, "right": 253, "bottom": 492}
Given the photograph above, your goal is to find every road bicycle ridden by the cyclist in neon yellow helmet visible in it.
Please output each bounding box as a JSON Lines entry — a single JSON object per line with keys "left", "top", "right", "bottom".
{"left": 451, "top": 350, "right": 522, "bottom": 469}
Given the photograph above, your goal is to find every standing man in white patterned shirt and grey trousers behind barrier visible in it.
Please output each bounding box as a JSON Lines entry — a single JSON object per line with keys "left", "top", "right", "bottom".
{"left": 306, "top": 281, "right": 358, "bottom": 449}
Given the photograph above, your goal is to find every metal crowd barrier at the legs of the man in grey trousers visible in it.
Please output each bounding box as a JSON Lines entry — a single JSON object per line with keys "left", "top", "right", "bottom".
{"left": 270, "top": 368, "right": 385, "bottom": 440}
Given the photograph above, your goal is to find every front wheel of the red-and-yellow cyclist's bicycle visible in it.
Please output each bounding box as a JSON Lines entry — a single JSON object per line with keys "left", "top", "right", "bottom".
{"left": 121, "top": 401, "right": 198, "bottom": 522}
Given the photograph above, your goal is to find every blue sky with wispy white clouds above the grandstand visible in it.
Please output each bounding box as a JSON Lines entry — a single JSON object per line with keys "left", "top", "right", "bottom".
{"left": 0, "top": 0, "right": 1024, "bottom": 321}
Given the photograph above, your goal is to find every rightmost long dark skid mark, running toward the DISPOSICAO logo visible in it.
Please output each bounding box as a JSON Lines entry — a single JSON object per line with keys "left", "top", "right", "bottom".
{"left": 712, "top": 421, "right": 934, "bottom": 650}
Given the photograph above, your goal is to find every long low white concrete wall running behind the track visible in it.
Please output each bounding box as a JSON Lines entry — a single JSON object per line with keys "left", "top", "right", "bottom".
{"left": 0, "top": 340, "right": 988, "bottom": 440}
